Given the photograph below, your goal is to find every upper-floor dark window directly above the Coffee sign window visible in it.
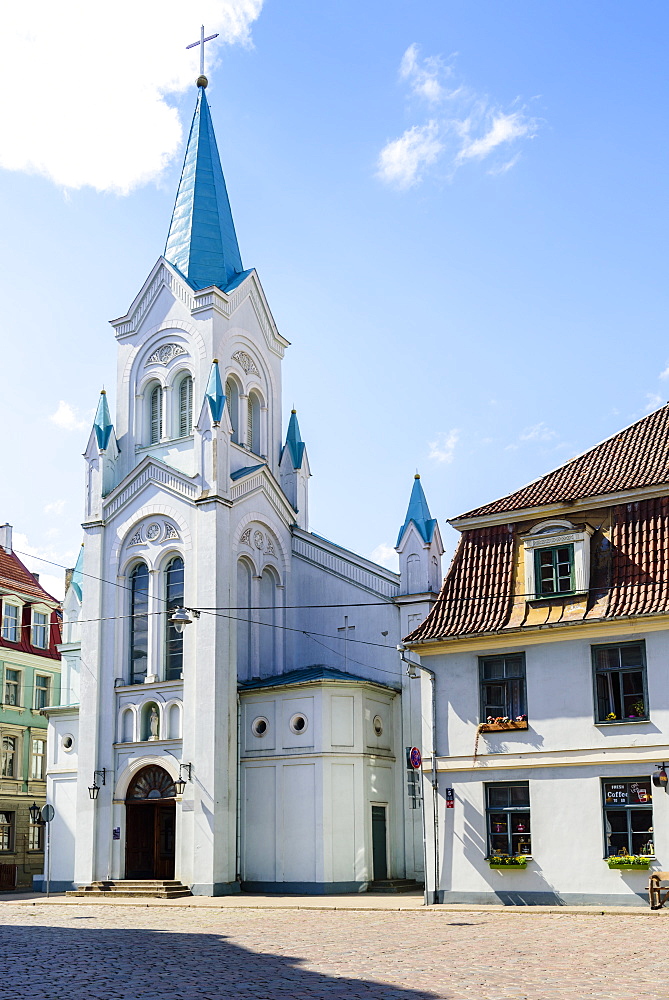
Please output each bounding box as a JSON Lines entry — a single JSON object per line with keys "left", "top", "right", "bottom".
{"left": 592, "top": 642, "right": 648, "bottom": 723}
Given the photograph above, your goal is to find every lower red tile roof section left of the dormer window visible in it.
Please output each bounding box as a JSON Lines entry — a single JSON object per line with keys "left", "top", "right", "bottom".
{"left": 407, "top": 524, "right": 513, "bottom": 642}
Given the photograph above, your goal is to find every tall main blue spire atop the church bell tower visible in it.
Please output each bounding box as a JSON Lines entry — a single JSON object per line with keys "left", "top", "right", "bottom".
{"left": 164, "top": 84, "right": 250, "bottom": 289}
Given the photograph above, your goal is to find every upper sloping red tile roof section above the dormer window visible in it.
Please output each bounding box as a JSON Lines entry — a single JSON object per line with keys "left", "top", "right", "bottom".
{"left": 454, "top": 404, "right": 669, "bottom": 521}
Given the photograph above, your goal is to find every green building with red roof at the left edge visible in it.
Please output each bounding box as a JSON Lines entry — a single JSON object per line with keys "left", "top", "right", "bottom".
{"left": 0, "top": 524, "right": 60, "bottom": 888}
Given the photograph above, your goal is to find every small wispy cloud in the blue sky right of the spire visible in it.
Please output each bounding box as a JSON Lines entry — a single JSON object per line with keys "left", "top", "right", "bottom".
{"left": 377, "top": 43, "right": 540, "bottom": 190}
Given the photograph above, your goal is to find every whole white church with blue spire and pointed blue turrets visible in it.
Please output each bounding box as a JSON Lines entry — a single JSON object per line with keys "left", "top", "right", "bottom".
{"left": 48, "top": 52, "right": 443, "bottom": 895}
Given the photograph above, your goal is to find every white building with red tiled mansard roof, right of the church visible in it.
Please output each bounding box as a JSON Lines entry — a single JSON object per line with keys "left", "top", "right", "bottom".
{"left": 405, "top": 405, "right": 669, "bottom": 905}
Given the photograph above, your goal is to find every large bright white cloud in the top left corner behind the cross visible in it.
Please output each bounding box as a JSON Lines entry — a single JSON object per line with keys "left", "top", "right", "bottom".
{"left": 0, "top": 0, "right": 263, "bottom": 194}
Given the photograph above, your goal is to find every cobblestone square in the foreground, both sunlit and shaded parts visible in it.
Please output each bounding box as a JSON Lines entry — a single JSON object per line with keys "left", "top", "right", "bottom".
{"left": 0, "top": 903, "right": 669, "bottom": 1000}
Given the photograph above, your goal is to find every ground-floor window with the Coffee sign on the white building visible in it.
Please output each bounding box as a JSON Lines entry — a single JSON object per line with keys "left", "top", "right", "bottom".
{"left": 602, "top": 778, "right": 655, "bottom": 858}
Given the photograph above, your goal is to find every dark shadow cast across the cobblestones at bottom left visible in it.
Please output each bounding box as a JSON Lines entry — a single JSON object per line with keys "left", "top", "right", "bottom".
{"left": 0, "top": 911, "right": 444, "bottom": 1000}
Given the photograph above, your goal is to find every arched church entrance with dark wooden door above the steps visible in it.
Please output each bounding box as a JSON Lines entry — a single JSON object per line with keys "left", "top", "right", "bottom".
{"left": 125, "top": 764, "right": 176, "bottom": 879}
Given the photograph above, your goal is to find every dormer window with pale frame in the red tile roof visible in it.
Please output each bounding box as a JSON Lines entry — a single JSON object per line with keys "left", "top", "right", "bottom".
{"left": 522, "top": 520, "right": 592, "bottom": 601}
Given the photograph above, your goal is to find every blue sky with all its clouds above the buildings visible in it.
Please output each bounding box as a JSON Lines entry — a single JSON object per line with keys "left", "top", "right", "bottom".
{"left": 0, "top": 0, "right": 669, "bottom": 596}
